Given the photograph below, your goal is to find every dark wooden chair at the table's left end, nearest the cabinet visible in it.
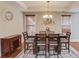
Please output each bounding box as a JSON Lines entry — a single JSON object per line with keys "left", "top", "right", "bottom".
{"left": 23, "top": 32, "right": 33, "bottom": 53}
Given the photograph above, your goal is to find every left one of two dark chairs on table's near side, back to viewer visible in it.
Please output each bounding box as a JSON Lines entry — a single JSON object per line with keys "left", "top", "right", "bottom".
{"left": 36, "top": 34, "right": 46, "bottom": 57}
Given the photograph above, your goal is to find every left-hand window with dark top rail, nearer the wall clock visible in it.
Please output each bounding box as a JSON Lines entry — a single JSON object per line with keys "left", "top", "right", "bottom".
{"left": 25, "top": 15, "right": 36, "bottom": 35}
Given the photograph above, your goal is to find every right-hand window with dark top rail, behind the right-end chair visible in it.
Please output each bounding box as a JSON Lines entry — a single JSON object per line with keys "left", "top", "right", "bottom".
{"left": 61, "top": 15, "right": 71, "bottom": 33}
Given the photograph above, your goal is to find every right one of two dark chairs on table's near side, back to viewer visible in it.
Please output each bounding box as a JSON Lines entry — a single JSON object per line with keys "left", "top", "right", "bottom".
{"left": 48, "top": 34, "right": 61, "bottom": 57}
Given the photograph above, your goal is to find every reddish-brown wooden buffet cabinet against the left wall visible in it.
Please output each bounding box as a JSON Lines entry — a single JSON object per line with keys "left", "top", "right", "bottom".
{"left": 1, "top": 34, "right": 21, "bottom": 57}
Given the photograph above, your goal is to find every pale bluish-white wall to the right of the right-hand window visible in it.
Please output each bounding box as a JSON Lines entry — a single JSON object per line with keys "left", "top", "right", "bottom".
{"left": 71, "top": 12, "right": 79, "bottom": 42}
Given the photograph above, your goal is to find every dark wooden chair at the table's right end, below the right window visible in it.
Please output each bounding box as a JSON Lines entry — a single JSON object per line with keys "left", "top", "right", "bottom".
{"left": 60, "top": 32, "right": 71, "bottom": 52}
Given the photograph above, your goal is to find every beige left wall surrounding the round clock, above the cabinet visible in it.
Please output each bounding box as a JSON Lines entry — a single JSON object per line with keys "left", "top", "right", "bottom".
{"left": 0, "top": 2, "right": 23, "bottom": 37}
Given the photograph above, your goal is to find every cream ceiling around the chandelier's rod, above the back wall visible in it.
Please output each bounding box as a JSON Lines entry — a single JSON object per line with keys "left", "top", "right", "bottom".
{"left": 16, "top": 1, "right": 79, "bottom": 12}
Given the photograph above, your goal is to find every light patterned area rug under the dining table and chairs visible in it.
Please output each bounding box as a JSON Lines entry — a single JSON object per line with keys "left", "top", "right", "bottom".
{"left": 16, "top": 47, "right": 79, "bottom": 58}
